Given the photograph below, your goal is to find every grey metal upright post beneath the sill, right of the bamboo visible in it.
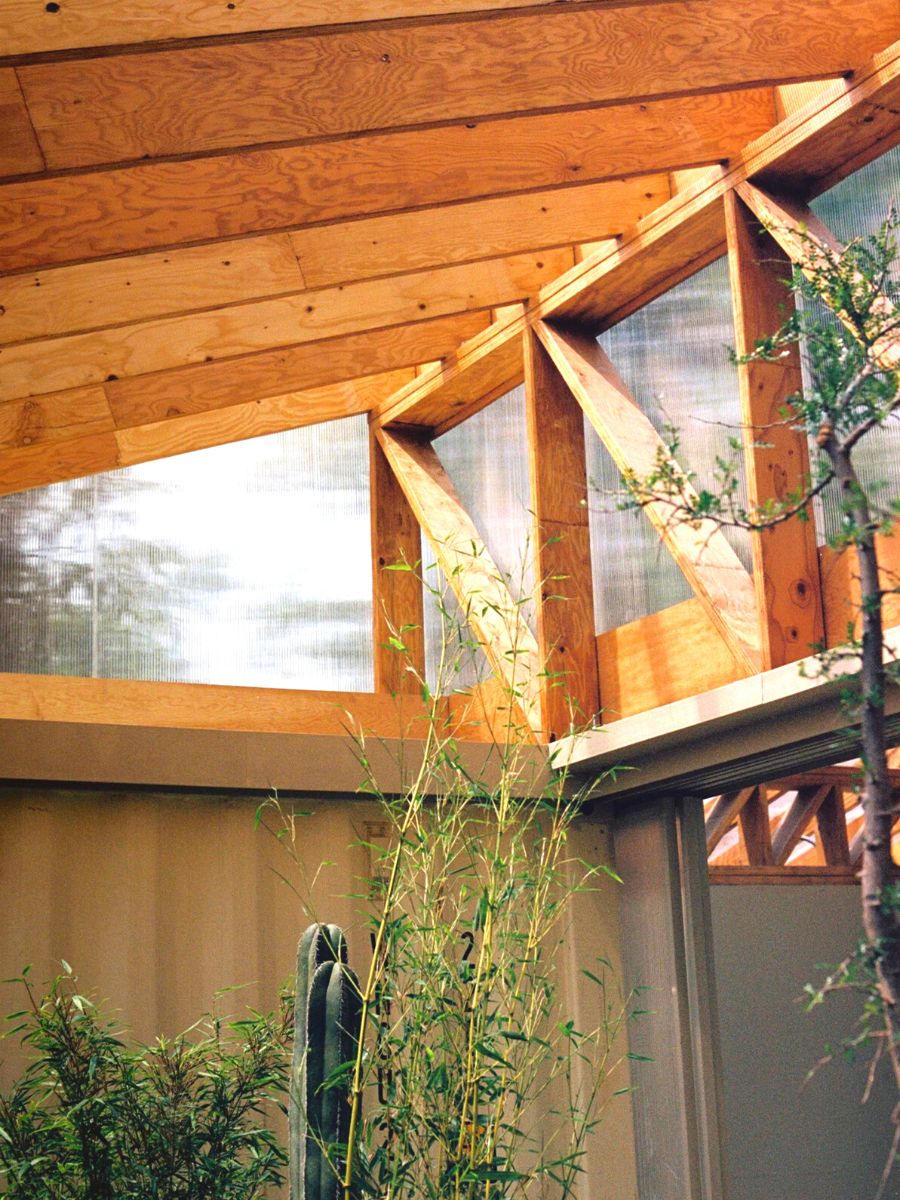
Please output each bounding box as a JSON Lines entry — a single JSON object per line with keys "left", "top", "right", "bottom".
{"left": 613, "top": 798, "right": 722, "bottom": 1200}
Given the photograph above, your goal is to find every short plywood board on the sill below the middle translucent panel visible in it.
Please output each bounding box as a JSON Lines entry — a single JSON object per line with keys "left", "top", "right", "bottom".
{"left": 596, "top": 599, "right": 749, "bottom": 724}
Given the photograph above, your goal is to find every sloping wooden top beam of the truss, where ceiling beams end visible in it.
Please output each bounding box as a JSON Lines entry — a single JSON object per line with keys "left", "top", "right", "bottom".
{"left": 379, "top": 42, "right": 900, "bottom": 439}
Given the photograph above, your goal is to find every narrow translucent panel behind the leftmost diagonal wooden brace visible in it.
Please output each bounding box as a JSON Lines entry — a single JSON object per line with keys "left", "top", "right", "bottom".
{"left": 422, "top": 388, "right": 534, "bottom": 686}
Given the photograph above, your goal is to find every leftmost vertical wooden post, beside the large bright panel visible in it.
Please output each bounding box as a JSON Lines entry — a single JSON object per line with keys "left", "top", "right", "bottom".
{"left": 368, "top": 427, "right": 425, "bottom": 695}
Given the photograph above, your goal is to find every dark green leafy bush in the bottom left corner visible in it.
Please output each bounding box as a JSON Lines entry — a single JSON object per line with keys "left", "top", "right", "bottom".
{"left": 0, "top": 967, "right": 287, "bottom": 1200}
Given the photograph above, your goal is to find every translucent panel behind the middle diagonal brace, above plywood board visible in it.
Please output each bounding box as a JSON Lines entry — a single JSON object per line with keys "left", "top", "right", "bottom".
{"left": 586, "top": 259, "right": 750, "bottom": 631}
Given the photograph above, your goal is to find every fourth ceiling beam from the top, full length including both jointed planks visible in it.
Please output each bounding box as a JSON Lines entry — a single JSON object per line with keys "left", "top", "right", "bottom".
{"left": 0, "top": 182, "right": 670, "bottom": 343}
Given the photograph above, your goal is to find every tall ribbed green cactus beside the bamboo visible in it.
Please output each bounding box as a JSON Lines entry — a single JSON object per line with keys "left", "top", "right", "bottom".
{"left": 289, "top": 925, "right": 360, "bottom": 1200}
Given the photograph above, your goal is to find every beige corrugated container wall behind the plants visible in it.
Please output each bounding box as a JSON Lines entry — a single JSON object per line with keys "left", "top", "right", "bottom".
{"left": 0, "top": 787, "right": 635, "bottom": 1200}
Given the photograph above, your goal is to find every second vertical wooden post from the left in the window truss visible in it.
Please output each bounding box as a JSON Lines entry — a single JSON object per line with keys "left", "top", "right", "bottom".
{"left": 524, "top": 332, "right": 600, "bottom": 742}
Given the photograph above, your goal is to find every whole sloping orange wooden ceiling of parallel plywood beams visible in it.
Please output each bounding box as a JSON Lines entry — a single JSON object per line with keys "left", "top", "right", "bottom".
{"left": 0, "top": 0, "right": 900, "bottom": 492}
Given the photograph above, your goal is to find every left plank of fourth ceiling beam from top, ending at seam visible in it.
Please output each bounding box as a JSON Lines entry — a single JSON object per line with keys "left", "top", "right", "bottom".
{"left": 0, "top": 234, "right": 305, "bottom": 343}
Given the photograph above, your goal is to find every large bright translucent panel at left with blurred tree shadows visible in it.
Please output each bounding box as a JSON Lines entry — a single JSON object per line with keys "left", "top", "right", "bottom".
{"left": 0, "top": 416, "right": 372, "bottom": 690}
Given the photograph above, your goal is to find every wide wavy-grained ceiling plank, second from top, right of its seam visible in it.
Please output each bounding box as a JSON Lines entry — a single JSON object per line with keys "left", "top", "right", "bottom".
{"left": 19, "top": 0, "right": 900, "bottom": 169}
